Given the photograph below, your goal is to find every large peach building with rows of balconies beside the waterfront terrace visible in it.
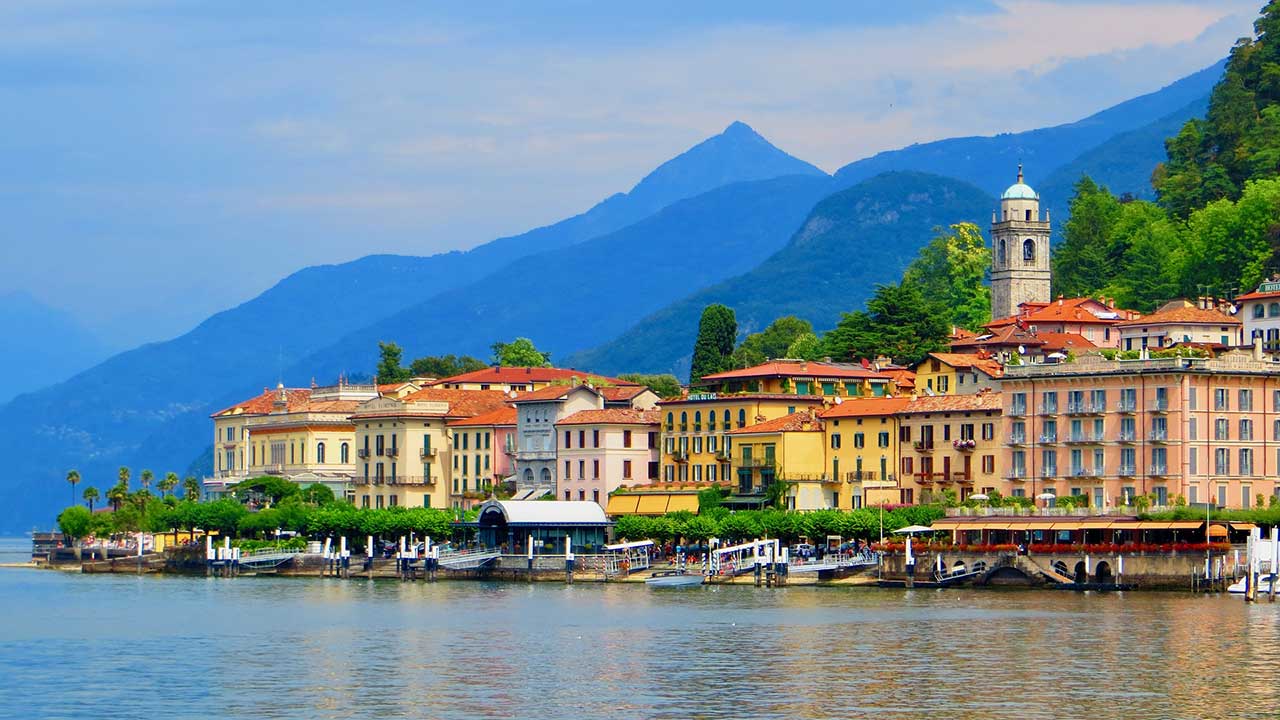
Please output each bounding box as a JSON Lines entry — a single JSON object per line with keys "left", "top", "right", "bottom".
{"left": 1001, "top": 350, "right": 1280, "bottom": 510}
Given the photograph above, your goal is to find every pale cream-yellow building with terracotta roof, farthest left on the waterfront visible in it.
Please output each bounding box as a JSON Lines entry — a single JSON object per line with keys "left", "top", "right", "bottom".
{"left": 204, "top": 383, "right": 378, "bottom": 497}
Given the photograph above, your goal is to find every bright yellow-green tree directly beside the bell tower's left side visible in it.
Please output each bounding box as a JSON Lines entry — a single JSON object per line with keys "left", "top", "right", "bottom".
{"left": 902, "top": 223, "right": 991, "bottom": 331}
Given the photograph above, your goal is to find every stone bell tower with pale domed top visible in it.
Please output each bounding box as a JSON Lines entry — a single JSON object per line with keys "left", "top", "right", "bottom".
{"left": 991, "top": 164, "right": 1052, "bottom": 320}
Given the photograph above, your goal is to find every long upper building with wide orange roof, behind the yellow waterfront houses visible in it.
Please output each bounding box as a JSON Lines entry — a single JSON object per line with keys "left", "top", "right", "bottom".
{"left": 692, "top": 360, "right": 893, "bottom": 400}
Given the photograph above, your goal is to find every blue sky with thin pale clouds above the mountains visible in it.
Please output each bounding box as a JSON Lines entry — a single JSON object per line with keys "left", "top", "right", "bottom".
{"left": 0, "top": 0, "right": 1261, "bottom": 347}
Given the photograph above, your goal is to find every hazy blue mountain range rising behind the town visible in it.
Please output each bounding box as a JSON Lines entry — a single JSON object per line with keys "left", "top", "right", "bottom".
{"left": 0, "top": 58, "right": 1221, "bottom": 530}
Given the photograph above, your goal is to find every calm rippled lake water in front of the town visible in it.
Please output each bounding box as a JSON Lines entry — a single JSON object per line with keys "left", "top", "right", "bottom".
{"left": 0, "top": 535, "right": 1280, "bottom": 720}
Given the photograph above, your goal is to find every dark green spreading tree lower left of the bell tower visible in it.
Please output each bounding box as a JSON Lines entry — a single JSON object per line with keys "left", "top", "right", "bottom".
{"left": 823, "top": 283, "right": 951, "bottom": 364}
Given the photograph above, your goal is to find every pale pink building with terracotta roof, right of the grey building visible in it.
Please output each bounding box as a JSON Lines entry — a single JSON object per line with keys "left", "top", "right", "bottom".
{"left": 556, "top": 407, "right": 659, "bottom": 507}
